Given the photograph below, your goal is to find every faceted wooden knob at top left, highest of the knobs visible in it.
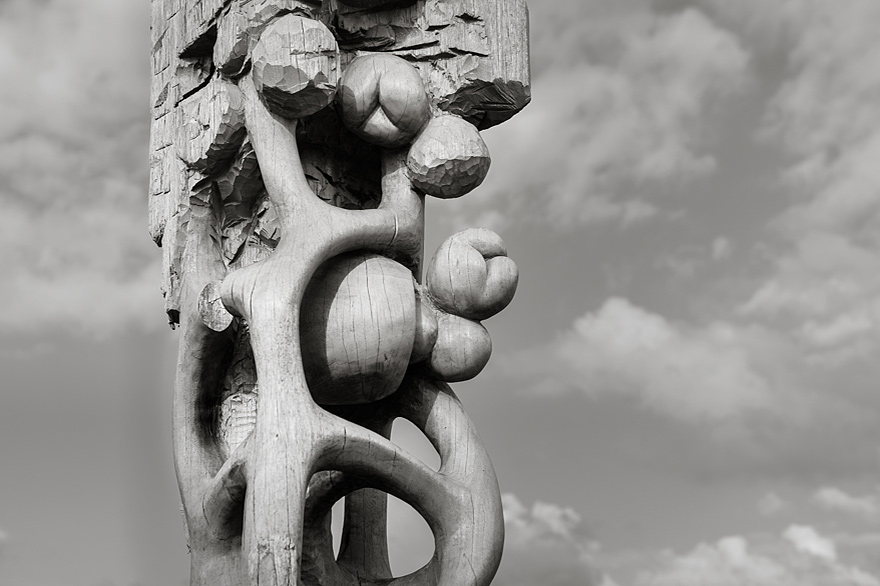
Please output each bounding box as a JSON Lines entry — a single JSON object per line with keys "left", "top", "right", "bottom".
{"left": 252, "top": 14, "right": 339, "bottom": 118}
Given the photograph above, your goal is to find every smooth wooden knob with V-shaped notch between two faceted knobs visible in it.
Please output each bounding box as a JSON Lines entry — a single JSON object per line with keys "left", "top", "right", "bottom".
{"left": 339, "top": 54, "right": 429, "bottom": 148}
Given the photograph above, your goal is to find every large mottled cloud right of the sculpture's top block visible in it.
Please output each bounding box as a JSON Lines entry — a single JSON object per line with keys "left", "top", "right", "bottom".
{"left": 457, "top": 4, "right": 749, "bottom": 229}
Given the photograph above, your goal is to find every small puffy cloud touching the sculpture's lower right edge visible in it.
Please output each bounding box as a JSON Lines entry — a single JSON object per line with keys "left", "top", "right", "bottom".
{"left": 493, "top": 494, "right": 612, "bottom": 586}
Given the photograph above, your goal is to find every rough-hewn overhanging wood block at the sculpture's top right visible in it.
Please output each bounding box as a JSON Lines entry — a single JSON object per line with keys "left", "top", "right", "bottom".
{"left": 322, "top": 0, "right": 531, "bottom": 130}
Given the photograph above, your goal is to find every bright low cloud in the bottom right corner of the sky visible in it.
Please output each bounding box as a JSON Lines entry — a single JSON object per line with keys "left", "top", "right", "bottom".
{"left": 634, "top": 525, "right": 880, "bottom": 586}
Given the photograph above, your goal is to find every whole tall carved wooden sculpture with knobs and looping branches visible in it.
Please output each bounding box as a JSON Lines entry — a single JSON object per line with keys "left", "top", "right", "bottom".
{"left": 150, "top": 0, "right": 529, "bottom": 586}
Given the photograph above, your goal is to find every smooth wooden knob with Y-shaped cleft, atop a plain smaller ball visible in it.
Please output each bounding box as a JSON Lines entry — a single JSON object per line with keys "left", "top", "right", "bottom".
{"left": 426, "top": 228, "right": 519, "bottom": 320}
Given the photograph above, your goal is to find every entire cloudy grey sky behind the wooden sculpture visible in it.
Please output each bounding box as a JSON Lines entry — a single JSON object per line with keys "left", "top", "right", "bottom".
{"left": 0, "top": 0, "right": 880, "bottom": 586}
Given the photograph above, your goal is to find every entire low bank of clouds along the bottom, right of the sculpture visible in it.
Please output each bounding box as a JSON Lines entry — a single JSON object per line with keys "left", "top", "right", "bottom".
{"left": 494, "top": 494, "right": 880, "bottom": 586}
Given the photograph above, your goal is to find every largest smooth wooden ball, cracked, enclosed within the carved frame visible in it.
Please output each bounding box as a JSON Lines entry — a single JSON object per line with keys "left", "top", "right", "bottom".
{"left": 300, "top": 253, "right": 417, "bottom": 405}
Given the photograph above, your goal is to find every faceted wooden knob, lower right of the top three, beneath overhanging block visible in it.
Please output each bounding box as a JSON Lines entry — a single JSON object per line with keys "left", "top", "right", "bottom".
{"left": 406, "top": 114, "right": 491, "bottom": 199}
